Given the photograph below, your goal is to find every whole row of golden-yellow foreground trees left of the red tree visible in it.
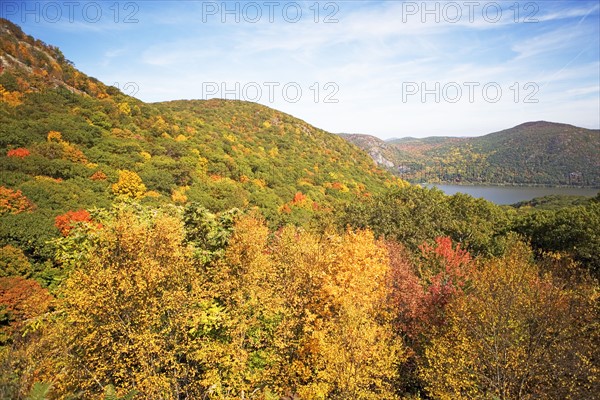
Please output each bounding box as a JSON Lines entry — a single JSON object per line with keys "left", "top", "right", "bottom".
{"left": 16, "top": 210, "right": 404, "bottom": 399}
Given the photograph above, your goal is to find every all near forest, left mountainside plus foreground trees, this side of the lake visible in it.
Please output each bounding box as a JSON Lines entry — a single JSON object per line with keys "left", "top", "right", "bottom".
{"left": 0, "top": 20, "right": 600, "bottom": 400}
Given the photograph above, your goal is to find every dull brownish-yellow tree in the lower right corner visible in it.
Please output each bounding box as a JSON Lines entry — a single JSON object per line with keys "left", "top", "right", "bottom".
{"left": 421, "top": 242, "right": 599, "bottom": 400}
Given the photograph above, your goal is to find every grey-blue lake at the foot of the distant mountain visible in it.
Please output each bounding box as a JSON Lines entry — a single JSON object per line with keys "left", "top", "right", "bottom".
{"left": 426, "top": 185, "right": 600, "bottom": 204}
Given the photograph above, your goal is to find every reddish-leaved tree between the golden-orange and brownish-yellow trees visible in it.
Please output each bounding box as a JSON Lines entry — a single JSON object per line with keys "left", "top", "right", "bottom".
{"left": 386, "top": 237, "right": 474, "bottom": 393}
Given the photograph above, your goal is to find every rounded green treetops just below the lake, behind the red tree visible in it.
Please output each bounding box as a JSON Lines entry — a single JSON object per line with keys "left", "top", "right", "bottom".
{"left": 340, "top": 186, "right": 508, "bottom": 256}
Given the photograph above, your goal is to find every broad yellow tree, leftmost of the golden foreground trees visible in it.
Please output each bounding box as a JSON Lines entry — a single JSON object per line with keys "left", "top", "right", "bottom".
{"left": 50, "top": 209, "right": 220, "bottom": 399}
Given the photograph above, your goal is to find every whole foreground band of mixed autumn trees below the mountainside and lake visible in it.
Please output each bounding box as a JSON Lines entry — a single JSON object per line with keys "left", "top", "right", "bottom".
{"left": 0, "top": 187, "right": 600, "bottom": 399}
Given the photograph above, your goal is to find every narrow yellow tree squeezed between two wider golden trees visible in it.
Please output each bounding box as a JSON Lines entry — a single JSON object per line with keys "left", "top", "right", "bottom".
{"left": 196, "top": 216, "right": 283, "bottom": 399}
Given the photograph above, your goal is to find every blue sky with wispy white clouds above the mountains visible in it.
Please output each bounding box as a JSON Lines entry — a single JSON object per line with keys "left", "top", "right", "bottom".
{"left": 0, "top": 0, "right": 600, "bottom": 139}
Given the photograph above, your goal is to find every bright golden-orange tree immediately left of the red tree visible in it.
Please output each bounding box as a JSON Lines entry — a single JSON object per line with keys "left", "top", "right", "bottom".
{"left": 273, "top": 228, "right": 404, "bottom": 399}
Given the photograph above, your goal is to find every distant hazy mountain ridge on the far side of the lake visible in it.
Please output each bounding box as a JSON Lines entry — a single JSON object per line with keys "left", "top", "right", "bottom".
{"left": 342, "top": 121, "right": 600, "bottom": 187}
